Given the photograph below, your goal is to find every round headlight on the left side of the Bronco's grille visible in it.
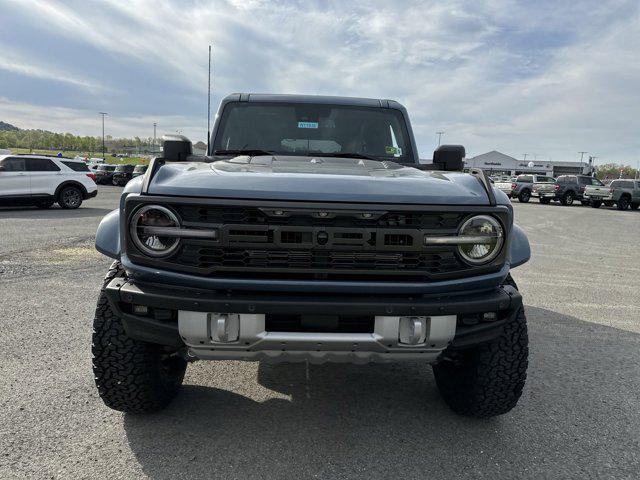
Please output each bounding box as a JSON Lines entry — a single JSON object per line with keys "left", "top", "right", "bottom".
{"left": 129, "top": 205, "right": 180, "bottom": 257}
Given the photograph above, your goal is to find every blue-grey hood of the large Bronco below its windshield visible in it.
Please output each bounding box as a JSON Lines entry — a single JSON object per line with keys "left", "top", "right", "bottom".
{"left": 147, "top": 155, "right": 489, "bottom": 205}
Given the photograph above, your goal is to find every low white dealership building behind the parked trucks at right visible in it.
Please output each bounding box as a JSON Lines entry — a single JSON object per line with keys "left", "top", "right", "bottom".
{"left": 465, "top": 150, "right": 595, "bottom": 177}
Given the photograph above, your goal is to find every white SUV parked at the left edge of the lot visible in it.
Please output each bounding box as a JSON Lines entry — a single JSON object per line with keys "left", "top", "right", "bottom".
{"left": 0, "top": 155, "right": 98, "bottom": 208}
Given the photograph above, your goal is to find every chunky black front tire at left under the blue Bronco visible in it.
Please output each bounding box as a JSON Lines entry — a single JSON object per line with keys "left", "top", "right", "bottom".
{"left": 91, "top": 262, "right": 187, "bottom": 413}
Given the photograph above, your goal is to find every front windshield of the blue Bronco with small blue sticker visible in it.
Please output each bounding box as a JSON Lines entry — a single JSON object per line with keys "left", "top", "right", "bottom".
{"left": 213, "top": 102, "right": 413, "bottom": 162}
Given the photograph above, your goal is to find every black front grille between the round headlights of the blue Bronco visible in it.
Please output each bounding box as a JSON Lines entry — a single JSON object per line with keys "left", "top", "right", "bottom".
{"left": 126, "top": 201, "right": 504, "bottom": 281}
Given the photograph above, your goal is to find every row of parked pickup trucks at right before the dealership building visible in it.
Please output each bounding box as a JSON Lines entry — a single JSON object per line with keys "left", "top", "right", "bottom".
{"left": 492, "top": 174, "right": 640, "bottom": 210}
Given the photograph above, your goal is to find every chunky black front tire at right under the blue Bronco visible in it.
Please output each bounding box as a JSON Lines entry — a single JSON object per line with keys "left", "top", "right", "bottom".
{"left": 433, "top": 277, "right": 529, "bottom": 418}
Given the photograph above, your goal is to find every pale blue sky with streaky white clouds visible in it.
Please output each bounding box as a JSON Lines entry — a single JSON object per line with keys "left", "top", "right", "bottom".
{"left": 0, "top": 0, "right": 640, "bottom": 167}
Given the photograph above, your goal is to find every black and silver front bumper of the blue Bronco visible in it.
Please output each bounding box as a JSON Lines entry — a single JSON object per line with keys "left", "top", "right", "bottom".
{"left": 106, "top": 278, "right": 522, "bottom": 363}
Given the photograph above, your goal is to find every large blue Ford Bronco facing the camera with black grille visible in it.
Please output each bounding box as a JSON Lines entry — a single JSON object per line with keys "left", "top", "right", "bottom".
{"left": 92, "top": 94, "right": 530, "bottom": 417}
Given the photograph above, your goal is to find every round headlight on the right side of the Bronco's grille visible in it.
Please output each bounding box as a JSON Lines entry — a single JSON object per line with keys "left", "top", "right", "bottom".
{"left": 458, "top": 215, "right": 504, "bottom": 265}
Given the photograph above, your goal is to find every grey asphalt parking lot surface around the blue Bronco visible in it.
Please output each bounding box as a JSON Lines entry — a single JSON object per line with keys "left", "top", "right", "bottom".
{"left": 0, "top": 187, "right": 640, "bottom": 479}
